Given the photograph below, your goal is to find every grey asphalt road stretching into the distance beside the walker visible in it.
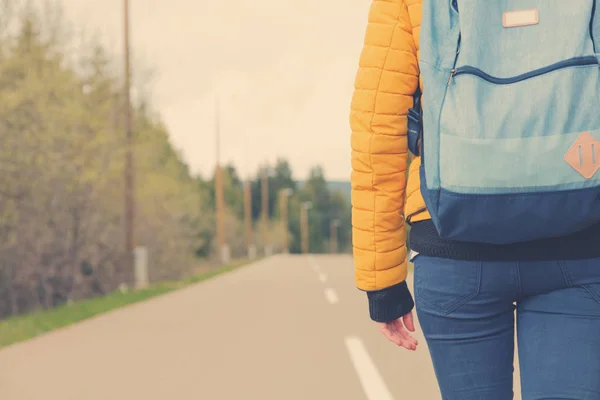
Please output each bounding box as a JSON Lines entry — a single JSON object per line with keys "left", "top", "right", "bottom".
{"left": 0, "top": 255, "right": 524, "bottom": 400}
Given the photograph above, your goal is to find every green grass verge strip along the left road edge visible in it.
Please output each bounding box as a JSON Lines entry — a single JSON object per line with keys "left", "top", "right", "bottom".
{"left": 0, "top": 260, "right": 253, "bottom": 348}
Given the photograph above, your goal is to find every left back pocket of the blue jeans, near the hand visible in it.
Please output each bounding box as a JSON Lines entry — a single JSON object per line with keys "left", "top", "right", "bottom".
{"left": 414, "top": 255, "right": 482, "bottom": 314}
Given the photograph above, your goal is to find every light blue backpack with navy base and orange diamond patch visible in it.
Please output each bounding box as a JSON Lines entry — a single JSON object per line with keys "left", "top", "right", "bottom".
{"left": 409, "top": 0, "right": 600, "bottom": 246}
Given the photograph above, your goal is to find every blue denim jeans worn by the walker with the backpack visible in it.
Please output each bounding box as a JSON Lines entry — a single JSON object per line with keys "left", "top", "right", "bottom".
{"left": 414, "top": 256, "right": 600, "bottom": 400}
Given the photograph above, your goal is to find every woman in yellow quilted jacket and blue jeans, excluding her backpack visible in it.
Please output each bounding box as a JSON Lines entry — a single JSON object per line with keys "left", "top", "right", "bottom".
{"left": 351, "top": 0, "right": 600, "bottom": 400}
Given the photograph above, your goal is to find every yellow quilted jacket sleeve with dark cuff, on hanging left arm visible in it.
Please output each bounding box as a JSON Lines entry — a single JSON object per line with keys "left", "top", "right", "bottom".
{"left": 350, "top": 0, "right": 419, "bottom": 322}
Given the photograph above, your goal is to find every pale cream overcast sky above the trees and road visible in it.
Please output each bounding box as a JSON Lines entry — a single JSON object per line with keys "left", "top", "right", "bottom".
{"left": 62, "top": 0, "right": 369, "bottom": 180}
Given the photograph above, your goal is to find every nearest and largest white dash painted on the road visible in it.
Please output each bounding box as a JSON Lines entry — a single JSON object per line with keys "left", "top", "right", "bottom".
{"left": 345, "top": 336, "right": 394, "bottom": 400}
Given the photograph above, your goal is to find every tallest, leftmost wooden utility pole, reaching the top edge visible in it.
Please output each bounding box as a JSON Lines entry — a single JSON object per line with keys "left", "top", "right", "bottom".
{"left": 123, "top": 0, "right": 135, "bottom": 264}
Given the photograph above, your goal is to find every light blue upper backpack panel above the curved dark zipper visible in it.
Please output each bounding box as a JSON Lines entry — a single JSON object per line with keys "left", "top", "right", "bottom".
{"left": 456, "top": 0, "right": 599, "bottom": 77}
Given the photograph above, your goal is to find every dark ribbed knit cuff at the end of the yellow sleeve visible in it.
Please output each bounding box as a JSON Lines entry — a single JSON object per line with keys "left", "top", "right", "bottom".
{"left": 367, "top": 281, "right": 415, "bottom": 322}
